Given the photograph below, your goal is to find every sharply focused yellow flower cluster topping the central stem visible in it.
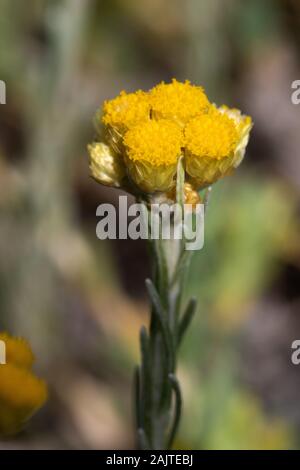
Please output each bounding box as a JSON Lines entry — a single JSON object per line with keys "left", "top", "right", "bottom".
{"left": 89, "top": 79, "right": 252, "bottom": 193}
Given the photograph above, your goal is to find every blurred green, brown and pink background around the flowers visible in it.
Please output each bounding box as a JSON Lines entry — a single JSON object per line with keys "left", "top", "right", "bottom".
{"left": 0, "top": 0, "right": 300, "bottom": 449}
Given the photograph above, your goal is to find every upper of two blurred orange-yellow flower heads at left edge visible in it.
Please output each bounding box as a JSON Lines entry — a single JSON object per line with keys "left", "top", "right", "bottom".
{"left": 0, "top": 333, "right": 34, "bottom": 369}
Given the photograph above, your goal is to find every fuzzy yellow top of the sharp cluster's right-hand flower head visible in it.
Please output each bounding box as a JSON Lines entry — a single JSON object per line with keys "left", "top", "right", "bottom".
{"left": 185, "top": 111, "right": 238, "bottom": 159}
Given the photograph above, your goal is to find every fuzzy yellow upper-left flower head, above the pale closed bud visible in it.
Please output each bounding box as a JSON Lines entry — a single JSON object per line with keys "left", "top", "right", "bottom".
{"left": 102, "top": 90, "right": 150, "bottom": 129}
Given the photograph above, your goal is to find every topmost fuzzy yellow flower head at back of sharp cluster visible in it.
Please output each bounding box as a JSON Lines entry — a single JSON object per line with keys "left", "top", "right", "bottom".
{"left": 150, "top": 79, "right": 210, "bottom": 126}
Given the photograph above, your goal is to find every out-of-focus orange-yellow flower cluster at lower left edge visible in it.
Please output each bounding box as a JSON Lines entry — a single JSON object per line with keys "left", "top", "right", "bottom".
{"left": 0, "top": 333, "right": 47, "bottom": 436}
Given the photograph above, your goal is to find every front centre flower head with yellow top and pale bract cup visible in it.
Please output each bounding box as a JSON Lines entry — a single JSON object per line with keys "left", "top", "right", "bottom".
{"left": 124, "top": 119, "right": 183, "bottom": 192}
